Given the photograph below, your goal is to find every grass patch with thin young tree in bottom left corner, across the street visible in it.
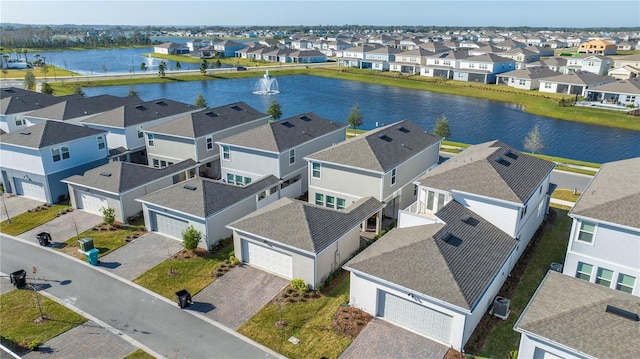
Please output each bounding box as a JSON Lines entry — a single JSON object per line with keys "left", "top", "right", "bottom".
{"left": 0, "top": 290, "right": 87, "bottom": 351}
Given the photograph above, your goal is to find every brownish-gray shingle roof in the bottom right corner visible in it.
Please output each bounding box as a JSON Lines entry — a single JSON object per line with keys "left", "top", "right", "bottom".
{"left": 514, "top": 271, "right": 640, "bottom": 359}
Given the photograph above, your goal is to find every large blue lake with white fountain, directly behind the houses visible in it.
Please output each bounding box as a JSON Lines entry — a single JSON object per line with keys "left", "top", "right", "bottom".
{"left": 84, "top": 75, "right": 640, "bottom": 163}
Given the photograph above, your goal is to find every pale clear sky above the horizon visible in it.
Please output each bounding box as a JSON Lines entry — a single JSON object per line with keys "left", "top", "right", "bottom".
{"left": 0, "top": 0, "right": 640, "bottom": 28}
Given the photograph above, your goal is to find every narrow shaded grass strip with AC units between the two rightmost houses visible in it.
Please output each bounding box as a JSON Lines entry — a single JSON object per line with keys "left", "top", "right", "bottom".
{"left": 467, "top": 209, "right": 571, "bottom": 359}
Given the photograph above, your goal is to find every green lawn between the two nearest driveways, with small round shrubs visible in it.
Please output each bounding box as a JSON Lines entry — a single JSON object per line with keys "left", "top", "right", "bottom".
{"left": 238, "top": 275, "right": 352, "bottom": 358}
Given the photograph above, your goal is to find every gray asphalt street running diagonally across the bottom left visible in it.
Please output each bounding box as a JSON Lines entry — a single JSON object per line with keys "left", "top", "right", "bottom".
{"left": 0, "top": 235, "right": 278, "bottom": 359}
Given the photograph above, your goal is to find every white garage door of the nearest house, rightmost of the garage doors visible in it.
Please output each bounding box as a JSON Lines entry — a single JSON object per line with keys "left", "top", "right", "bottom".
{"left": 378, "top": 291, "right": 452, "bottom": 344}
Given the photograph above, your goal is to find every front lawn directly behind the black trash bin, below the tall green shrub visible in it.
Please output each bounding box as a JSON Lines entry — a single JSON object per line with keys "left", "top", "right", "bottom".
{"left": 134, "top": 243, "right": 233, "bottom": 300}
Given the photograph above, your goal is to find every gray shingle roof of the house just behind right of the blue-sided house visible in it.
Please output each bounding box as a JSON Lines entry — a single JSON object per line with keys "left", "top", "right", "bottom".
{"left": 82, "top": 98, "right": 198, "bottom": 128}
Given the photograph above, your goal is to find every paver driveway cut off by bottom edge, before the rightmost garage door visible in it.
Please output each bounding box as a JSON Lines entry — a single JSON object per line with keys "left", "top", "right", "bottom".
{"left": 339, "top": 318, "right": 449, "bottom": 359}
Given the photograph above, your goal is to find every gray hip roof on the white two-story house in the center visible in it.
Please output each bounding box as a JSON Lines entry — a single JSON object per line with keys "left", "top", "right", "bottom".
{"left": 307, "top": 120, "right": 440, "bottom": 172}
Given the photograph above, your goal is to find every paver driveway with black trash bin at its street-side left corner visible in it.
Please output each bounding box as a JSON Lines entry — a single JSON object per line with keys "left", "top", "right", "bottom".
{"left": 187, "top": 265, "right": 289, "bottom": 330}
